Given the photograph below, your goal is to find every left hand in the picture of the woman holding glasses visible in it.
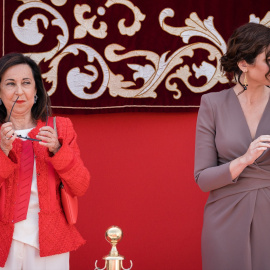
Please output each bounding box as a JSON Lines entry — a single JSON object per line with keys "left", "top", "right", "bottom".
{"left": 0, "top": 122, "right": 17, "bottom": 156}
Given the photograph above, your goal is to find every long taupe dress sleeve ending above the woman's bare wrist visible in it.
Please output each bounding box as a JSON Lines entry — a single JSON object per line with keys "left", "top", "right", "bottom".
{"left": 194, "top": 95, "right": 235, "bottom": 192}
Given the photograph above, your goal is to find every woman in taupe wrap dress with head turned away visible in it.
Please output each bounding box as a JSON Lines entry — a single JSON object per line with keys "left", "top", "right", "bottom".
{"left": 195, "top": 23, "right": 270, "bottom": 270}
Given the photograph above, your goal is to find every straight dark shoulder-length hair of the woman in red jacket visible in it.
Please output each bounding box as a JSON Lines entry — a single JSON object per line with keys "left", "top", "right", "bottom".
{"left": 0, "top": 53, "right": 52, "bottom": 123}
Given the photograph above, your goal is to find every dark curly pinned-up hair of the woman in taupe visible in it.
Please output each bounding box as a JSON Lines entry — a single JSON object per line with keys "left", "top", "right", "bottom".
{"left": 220, "top": 23, "right": 270, "bottom": 78}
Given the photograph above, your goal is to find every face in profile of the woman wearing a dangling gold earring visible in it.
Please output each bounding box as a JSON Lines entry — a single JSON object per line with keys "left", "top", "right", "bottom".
{"left": 247, "top": 48, "right": 270, "bottom": 85}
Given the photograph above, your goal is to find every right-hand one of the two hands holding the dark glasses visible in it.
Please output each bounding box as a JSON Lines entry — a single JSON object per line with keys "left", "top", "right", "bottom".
{"left": 37, "top": 126, "right": 61, "bottom": 154}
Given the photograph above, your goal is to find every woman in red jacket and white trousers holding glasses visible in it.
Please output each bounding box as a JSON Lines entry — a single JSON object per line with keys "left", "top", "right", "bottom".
{"left": 0, "top": 53, "right": 90, "bottom": 270}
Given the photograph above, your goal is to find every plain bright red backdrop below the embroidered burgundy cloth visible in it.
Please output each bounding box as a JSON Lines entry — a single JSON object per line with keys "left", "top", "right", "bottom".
{"left": 69, "top": 110, "right": 207, "bottom": 270}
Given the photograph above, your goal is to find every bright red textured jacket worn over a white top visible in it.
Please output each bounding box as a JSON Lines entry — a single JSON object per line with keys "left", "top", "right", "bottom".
{"left": 0, "top": 117, "right": 90, "bottom": 267}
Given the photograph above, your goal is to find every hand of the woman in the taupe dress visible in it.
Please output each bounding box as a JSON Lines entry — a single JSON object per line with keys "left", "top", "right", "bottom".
{"left": 242, "top": 135, "right": 270, "bottom": 166}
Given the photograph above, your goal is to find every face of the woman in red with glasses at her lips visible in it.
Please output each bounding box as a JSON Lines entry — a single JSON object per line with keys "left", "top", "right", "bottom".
{"left": 0, "top": 64, "right": 37, "bottom": 117}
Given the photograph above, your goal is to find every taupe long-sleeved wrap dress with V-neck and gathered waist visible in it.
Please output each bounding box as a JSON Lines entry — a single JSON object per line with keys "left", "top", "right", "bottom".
{"left": 195, "top": 88, "right": 270, "bottom": 270}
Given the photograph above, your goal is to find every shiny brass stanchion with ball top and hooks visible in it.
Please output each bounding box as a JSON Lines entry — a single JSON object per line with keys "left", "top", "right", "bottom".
{"left": 95, "top": 226, "right": 133, "bottom": 270}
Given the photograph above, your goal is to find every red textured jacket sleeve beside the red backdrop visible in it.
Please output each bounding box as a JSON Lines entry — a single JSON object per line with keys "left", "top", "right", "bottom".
{"left": 48, "top": 117, "right": 90, "bottom": 196}
